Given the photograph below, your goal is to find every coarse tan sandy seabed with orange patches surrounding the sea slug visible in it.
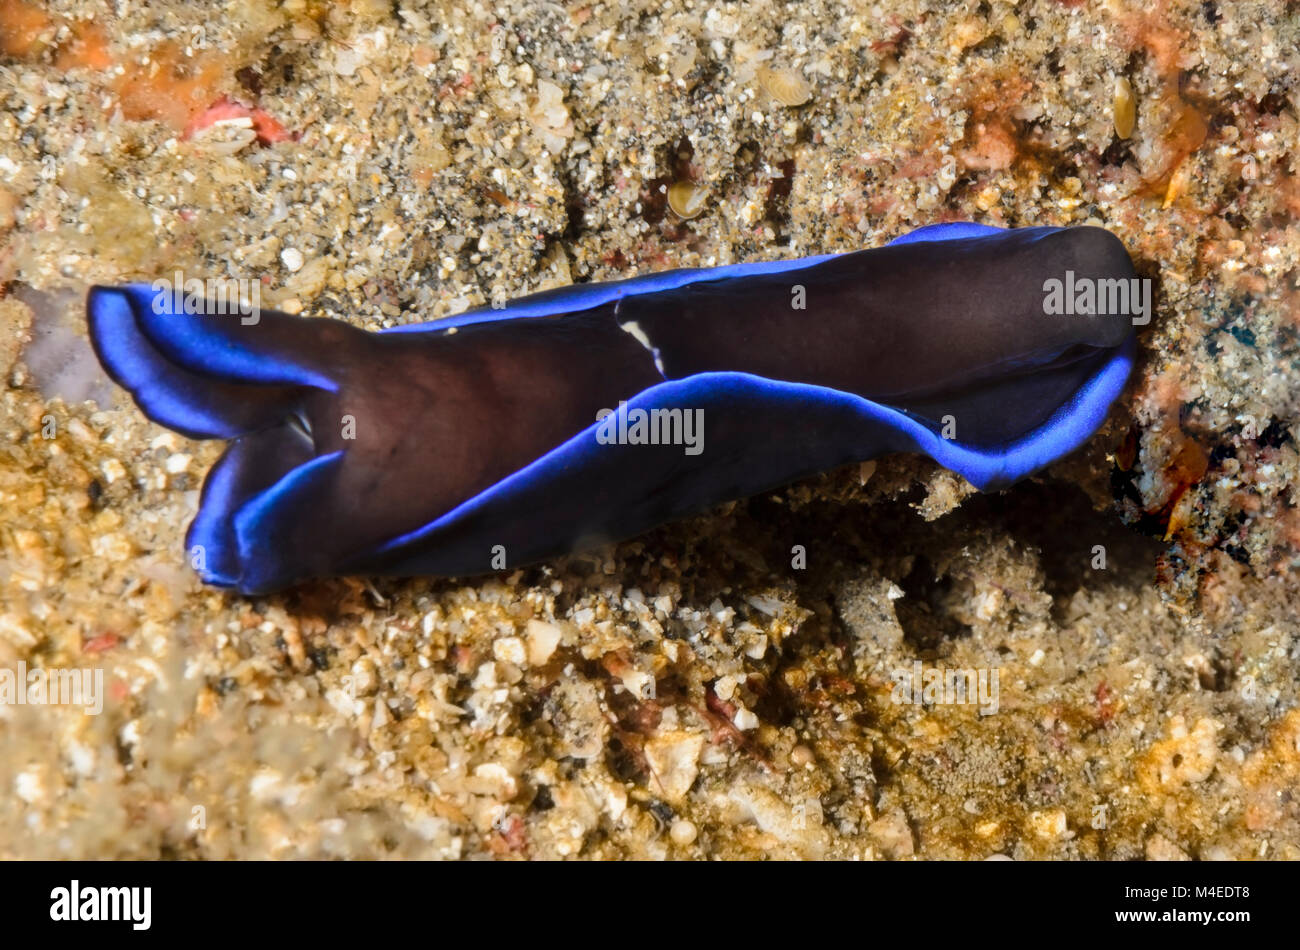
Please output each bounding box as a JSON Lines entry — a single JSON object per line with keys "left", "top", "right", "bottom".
{"left": 0, "top": 0, "right": 1300, "bottom": 859}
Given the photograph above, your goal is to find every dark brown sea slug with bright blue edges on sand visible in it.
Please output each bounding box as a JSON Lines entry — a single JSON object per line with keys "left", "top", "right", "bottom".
{"left": 87, "top": 224, "right": 1149, "bottom": 593}
